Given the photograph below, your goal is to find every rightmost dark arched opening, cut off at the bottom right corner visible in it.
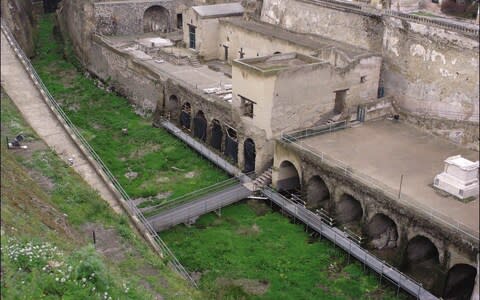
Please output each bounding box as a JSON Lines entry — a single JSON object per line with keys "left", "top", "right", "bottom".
{"left": 443, "top": 264, "right": 477, "bottom": 300}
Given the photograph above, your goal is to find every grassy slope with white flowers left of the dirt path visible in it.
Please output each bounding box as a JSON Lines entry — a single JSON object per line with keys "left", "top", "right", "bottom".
{"left": 1, "top": 91, "right": 198, "bottom": 299}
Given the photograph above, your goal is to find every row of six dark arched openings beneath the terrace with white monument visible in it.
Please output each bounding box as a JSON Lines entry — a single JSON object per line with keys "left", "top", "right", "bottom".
{"left": 276, "top": 160, "right": 477, "bottom": 299}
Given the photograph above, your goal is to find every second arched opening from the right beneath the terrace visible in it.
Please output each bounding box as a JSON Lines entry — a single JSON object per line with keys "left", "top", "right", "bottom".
{"left": 403, "top": 235, "right": 441, "bottom": 290}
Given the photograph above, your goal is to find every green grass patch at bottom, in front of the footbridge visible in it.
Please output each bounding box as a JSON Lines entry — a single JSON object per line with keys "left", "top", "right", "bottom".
{"left": 162, "top": 201, "right": 404, "bottom": 299}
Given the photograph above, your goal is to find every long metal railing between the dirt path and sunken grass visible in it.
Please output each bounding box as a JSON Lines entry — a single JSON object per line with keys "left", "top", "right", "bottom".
{"left": 1, "top": 20, "right": 198, "bottom": 287}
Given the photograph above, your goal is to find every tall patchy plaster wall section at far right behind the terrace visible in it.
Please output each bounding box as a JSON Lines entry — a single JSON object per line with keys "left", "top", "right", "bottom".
{"left": 382, "top": 18, "right": 479, "bottom": 122}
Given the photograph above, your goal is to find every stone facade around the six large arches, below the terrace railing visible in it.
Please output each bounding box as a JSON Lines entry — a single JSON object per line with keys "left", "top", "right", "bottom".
{"left": 272, "top": 141, "right": 479, "bottom": 270}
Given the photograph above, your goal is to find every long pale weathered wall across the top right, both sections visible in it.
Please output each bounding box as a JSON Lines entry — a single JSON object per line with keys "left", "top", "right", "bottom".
{"left": 261, "top": 0, "right": 479, "bottom": 145}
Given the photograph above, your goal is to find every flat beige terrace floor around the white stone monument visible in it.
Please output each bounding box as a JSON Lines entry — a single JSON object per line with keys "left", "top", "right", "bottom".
{"left": 302, "top": 120, "right": 479, "bottom": 236}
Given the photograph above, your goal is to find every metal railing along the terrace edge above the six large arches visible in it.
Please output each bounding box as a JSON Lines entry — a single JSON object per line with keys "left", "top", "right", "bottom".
{"left": 282, "top": 135, "right": 479, "bottom": 244}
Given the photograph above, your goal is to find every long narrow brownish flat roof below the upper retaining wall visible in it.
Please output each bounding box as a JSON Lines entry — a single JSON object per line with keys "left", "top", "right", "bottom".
{"left": 220, "top": 18, "right": 375, "bottom": 60}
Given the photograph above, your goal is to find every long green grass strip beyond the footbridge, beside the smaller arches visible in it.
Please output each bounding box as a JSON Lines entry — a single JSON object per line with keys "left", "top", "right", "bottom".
{"left": 33, "top": 15, "right": 228, "bottom": 205}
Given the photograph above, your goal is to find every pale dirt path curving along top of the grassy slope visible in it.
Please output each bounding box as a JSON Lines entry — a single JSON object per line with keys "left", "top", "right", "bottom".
{"left": 1, "top": 32, "right": 121, "bottom": 213}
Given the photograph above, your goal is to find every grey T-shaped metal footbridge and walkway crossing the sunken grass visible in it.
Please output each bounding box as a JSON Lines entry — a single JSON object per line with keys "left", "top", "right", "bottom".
{"left": 153, "top": 120, "right": 438, "bottom": 300}
